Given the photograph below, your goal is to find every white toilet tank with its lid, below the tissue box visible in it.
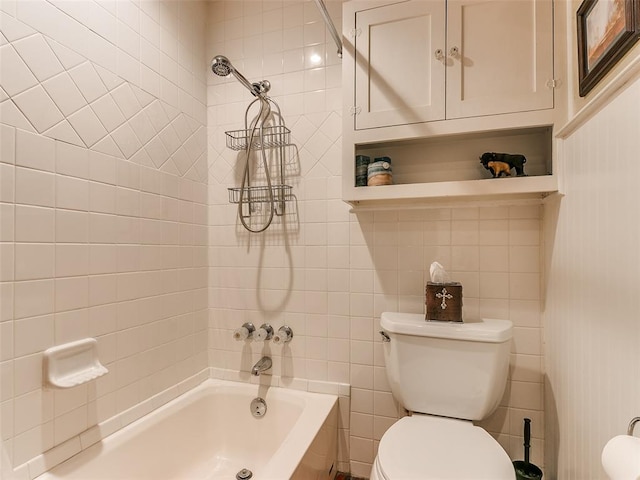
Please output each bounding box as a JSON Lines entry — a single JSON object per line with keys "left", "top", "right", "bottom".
{"left": 380, "top": 312, "right": 513, "bottom": 420}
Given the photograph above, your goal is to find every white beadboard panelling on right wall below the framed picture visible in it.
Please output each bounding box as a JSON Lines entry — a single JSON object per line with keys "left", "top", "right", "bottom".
{"left": 544, "top": 77, "right": 640, "bottom": 480}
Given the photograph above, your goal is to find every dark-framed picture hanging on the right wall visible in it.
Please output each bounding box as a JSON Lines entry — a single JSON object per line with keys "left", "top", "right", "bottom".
{"left": 577, "top": 0, "right": 640, "bottom": 97}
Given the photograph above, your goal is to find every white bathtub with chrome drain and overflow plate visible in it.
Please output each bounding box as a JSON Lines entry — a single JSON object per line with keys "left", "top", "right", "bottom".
{"left": 37, "top": 380, "right": 338, "bottom": 480}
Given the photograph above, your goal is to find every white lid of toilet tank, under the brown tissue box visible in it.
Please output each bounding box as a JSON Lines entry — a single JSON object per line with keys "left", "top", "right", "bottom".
{"left": 380, "top": 312, "right": 513, "bottom": 343}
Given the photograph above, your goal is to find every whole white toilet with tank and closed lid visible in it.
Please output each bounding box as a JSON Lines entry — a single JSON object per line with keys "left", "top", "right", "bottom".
{"left": 370, "top": 312, "right": 516, "bottom": 480}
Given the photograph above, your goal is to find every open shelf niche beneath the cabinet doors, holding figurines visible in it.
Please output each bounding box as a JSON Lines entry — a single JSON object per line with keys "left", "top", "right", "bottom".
{"left": 344, "top": 126, "right": 557, "bottom": 205}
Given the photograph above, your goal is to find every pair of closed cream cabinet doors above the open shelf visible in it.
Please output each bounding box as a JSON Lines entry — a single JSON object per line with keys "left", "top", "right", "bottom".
{"left": 350, "top": 0, "right": 553, "bottom": 130}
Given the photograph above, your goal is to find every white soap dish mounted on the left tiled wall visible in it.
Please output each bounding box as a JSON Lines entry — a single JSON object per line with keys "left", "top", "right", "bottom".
{"left": 44, "top": 338, "right": 109, "bottom": 388}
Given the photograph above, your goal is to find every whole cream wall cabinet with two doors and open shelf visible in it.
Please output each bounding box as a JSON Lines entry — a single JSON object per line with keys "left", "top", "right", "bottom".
{"left": 343, "top": 0, "right": 561, "bottom": 205}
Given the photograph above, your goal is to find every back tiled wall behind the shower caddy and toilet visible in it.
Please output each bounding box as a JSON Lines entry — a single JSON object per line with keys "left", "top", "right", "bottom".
{"left": 207, "top": 0, "right": 544, "bottom": 477}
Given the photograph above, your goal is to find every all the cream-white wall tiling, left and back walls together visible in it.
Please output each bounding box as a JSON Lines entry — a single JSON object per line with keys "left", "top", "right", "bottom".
{"left": 0, "top": 0, "right": 543, "bottom": 476}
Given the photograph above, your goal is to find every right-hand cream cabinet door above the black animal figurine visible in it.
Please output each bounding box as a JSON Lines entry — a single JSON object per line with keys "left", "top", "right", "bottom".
{"left": 447, "top": 0, "right": 553, "bottom": 118}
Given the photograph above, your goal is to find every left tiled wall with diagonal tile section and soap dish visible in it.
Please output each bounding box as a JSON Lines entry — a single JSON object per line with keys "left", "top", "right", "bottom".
{"left": 0, "top": 0, "right": 208, "bottom": 478}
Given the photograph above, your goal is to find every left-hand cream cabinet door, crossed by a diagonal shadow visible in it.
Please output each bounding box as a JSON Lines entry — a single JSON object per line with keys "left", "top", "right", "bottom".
{"left": 355, "top": 0, "right": 445, "bottom": 130}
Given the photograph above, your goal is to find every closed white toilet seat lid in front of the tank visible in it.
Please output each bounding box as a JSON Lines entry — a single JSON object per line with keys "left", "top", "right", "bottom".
{"left": 372, "top": 414, "right": 516, "bottom": 480}
